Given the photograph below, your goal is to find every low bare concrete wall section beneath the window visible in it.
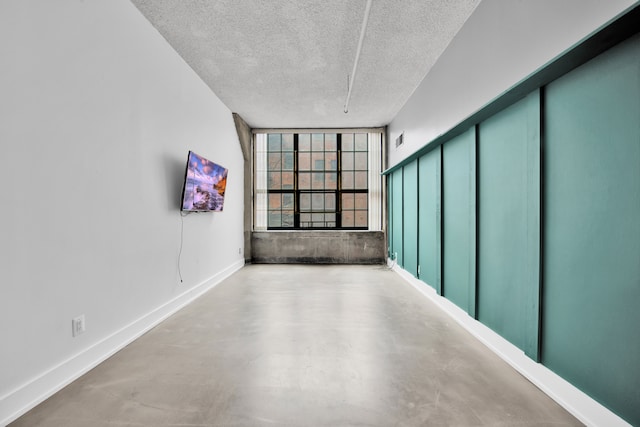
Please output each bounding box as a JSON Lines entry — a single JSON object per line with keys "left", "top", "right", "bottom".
{"left": 251, "top": 230, "right": 386, "bottom": 264}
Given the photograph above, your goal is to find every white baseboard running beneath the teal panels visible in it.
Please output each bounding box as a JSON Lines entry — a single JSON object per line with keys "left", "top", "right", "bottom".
{"left": 388, "top": 261, "right": 631, "bottom": 427}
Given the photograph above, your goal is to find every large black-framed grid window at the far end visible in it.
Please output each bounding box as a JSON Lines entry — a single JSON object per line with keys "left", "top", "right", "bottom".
{"left": 254, "top": 132, "right": 380, "bottom": 230}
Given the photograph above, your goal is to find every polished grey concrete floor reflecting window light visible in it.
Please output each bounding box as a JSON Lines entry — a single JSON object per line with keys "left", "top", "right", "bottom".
{"left": 11, "top": 265, "right": 581, "bottom": 427}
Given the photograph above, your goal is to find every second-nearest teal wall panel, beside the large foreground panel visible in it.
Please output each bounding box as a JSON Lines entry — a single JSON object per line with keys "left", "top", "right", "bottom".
{"left": 478, "top": 91, "right": 540, "bottom": 360}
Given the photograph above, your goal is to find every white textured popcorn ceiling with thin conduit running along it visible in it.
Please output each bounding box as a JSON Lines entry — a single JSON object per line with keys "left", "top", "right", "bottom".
{"left": 132, "top": 0, "right": 480, "bottom": 128}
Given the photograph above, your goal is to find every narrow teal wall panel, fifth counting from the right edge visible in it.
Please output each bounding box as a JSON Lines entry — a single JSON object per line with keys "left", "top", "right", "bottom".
{"left": 403, "top": 160, "right": 418, "bottom": 277}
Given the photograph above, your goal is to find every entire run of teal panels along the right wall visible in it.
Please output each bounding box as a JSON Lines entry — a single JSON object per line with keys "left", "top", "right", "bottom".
{"left": 385, "top": 7, "right": 640, "bottom": 426}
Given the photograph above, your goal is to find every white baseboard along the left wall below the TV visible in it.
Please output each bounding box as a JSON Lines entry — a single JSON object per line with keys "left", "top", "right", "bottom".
{"left": 0, "top": 259, "right": 244, "bottom": 426}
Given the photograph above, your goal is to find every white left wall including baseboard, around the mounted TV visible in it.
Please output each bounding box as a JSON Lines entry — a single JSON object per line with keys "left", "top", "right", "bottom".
{"left": 0, "top": 0, "right": 244, "bottom": 424}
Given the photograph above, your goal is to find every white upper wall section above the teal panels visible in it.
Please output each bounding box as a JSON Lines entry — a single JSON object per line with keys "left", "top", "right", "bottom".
{"left": 387, "top": 0, "right": 640, "bottom": 167}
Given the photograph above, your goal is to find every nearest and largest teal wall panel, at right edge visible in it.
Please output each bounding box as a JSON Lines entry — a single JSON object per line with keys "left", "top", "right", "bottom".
{"left": 542, "top": 36, "right": 640, "bottom": 425}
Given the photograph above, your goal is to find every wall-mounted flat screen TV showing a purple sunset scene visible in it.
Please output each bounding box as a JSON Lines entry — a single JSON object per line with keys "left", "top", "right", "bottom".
{"left": 181, "top": 151, "right": 227, "bottom": 212}
